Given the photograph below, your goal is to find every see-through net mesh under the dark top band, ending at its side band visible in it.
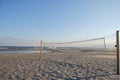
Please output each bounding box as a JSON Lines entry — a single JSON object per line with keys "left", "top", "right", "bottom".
{"left": 44, "top": 37, "right": 106, "bottom": 51}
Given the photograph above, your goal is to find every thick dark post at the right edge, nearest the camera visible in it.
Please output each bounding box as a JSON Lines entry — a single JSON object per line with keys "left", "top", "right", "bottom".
{"left": 115, "top": 31, "right": 120, "bottom": 75}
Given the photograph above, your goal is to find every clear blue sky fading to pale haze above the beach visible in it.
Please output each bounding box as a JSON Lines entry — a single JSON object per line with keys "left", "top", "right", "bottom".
{"left": 0, "top": 0, "right": 120, "bottom": 45}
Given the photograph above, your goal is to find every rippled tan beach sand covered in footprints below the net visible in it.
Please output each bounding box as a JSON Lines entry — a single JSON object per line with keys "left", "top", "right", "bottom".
{"left": 0, "top": 52, "right": 120, "bottom": 80}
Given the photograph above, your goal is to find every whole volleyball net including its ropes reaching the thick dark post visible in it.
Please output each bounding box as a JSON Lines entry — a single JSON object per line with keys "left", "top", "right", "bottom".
{"left": 43, "top": 34, "right": 116, "bottom": 52}
